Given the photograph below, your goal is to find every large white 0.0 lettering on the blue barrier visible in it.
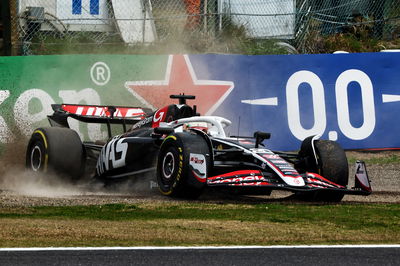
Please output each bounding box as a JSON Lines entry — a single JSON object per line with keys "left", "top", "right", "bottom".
{"left": 286, "top": 69, "right": 376, "bottom": 140}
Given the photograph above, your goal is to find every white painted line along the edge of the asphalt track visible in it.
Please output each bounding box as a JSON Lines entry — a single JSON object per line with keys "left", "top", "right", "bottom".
{"left": 0, "top": 244, "right": 400, "bottom": 252}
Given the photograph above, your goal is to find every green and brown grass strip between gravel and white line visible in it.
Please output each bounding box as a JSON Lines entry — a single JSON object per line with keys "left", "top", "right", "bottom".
{"left": 0, "top": 202, "right": 400, "bottom": 247}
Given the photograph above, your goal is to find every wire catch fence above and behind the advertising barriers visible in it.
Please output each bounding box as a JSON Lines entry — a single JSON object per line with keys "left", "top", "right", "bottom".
{"left": 9, "top": 0, "right": 400, "bottom": 55}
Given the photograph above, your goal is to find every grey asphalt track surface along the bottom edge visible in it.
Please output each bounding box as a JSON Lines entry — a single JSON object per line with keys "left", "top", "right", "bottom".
{"left": 0, "top": 245, "right": 400, "bottom": 266}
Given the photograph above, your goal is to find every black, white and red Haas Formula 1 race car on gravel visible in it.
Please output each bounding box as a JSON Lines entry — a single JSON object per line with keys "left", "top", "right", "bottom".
{"left": 26, "top": 95, "right": 371, "bottom": 201}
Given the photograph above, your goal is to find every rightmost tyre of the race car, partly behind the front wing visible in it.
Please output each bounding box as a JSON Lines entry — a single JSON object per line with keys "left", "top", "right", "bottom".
{"left": 298, "top": 140, "right": 349, "bottom": 202}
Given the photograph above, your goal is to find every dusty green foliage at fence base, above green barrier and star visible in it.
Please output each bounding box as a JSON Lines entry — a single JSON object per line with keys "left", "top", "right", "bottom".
{"left": 21, "top": 13, "right": 296, "bottom": 55}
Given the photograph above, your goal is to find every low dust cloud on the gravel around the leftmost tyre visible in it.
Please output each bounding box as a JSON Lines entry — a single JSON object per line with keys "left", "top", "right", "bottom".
{"left": 0, "top": 141, "right": 158, "bottom": 198}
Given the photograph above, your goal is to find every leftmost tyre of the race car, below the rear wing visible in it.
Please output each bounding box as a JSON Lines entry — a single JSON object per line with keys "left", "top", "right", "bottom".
{"left": 26, "top": 127, "right": 84, "bottom": 180}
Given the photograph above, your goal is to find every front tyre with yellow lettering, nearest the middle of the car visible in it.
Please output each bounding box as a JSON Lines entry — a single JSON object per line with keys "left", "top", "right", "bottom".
{"left": 157, "top": 132, "right": 210, "bottom": 199}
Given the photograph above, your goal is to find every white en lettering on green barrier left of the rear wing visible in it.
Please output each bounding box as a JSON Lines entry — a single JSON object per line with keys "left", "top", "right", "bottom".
{"left": 14, "top": 89, "right": 54, "bottom": 136}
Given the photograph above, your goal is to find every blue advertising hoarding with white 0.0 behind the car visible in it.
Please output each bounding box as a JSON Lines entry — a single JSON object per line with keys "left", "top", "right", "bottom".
{"left": 190, "top": 53, "right": 400, "bottom": 150}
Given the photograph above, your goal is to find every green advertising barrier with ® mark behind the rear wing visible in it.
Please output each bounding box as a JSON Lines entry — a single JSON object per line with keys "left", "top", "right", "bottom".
{"left": 0, "top": 55, "right": 168, "bottom": 144}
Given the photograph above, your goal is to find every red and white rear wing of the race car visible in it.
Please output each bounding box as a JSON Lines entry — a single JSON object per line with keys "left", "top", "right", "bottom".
{"left": 48, "top": 104, "right": 152, "bottom": 136}
